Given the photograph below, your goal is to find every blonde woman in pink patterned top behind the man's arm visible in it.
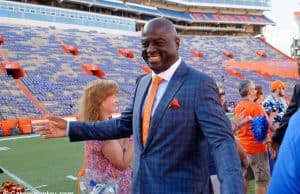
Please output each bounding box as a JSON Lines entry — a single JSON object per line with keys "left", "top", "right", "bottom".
{"left": 79, "top": 79, "right": 133, "bottom": 194}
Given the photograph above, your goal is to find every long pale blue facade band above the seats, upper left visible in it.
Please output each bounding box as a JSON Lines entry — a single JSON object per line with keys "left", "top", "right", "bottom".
{"left": 0, "top": 1, "right": 136, "bottom": 31}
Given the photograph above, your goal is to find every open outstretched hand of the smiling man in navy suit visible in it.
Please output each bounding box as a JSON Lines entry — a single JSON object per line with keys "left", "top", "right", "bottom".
{"left": 31, "top": 117, "right": 67, "bottom": 139}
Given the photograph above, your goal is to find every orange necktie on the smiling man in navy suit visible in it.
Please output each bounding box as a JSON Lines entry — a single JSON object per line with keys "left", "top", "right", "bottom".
{"left": 142, "top": 75, "right": 163, "bottom": 145}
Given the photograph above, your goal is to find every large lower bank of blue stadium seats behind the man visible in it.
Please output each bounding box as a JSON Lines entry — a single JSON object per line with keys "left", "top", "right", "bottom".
{"left": 0, "top": 21, "right": 296, "bottom": 117}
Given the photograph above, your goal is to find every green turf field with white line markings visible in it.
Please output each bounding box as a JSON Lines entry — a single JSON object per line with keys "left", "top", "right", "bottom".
{"left": 0, "top": 134, "right": 254, "bottom": 194}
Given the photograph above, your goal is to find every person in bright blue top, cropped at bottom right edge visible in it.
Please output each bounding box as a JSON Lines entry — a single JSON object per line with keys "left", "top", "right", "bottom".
{"left": 268, "top": 108, "right": 300, "bottom": 194}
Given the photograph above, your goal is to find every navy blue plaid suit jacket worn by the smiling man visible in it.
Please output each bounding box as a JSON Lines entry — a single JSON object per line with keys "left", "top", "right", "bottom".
{"left": 69, "top": 63, "right": 244, "bottom": 194}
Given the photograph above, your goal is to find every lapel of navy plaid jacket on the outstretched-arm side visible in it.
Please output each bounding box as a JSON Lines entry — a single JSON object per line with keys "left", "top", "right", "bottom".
{"left": 135, "top": 74, "right": 151, "bottom": 150}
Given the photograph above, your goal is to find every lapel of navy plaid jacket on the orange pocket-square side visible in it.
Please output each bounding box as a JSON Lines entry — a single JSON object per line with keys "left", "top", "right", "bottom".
{"left": 145, "top": 63, "right": 188, "bottom": 147}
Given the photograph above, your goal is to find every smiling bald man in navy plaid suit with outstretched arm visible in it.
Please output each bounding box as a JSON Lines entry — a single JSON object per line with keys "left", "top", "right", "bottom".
{"left": 33, "top": 18, "right": 244, "bottom": 194}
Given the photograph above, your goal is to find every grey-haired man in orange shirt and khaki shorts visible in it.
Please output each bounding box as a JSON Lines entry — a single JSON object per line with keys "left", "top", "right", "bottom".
{"left": 234, "top": 80, "right": 270, "bottom": 194}
